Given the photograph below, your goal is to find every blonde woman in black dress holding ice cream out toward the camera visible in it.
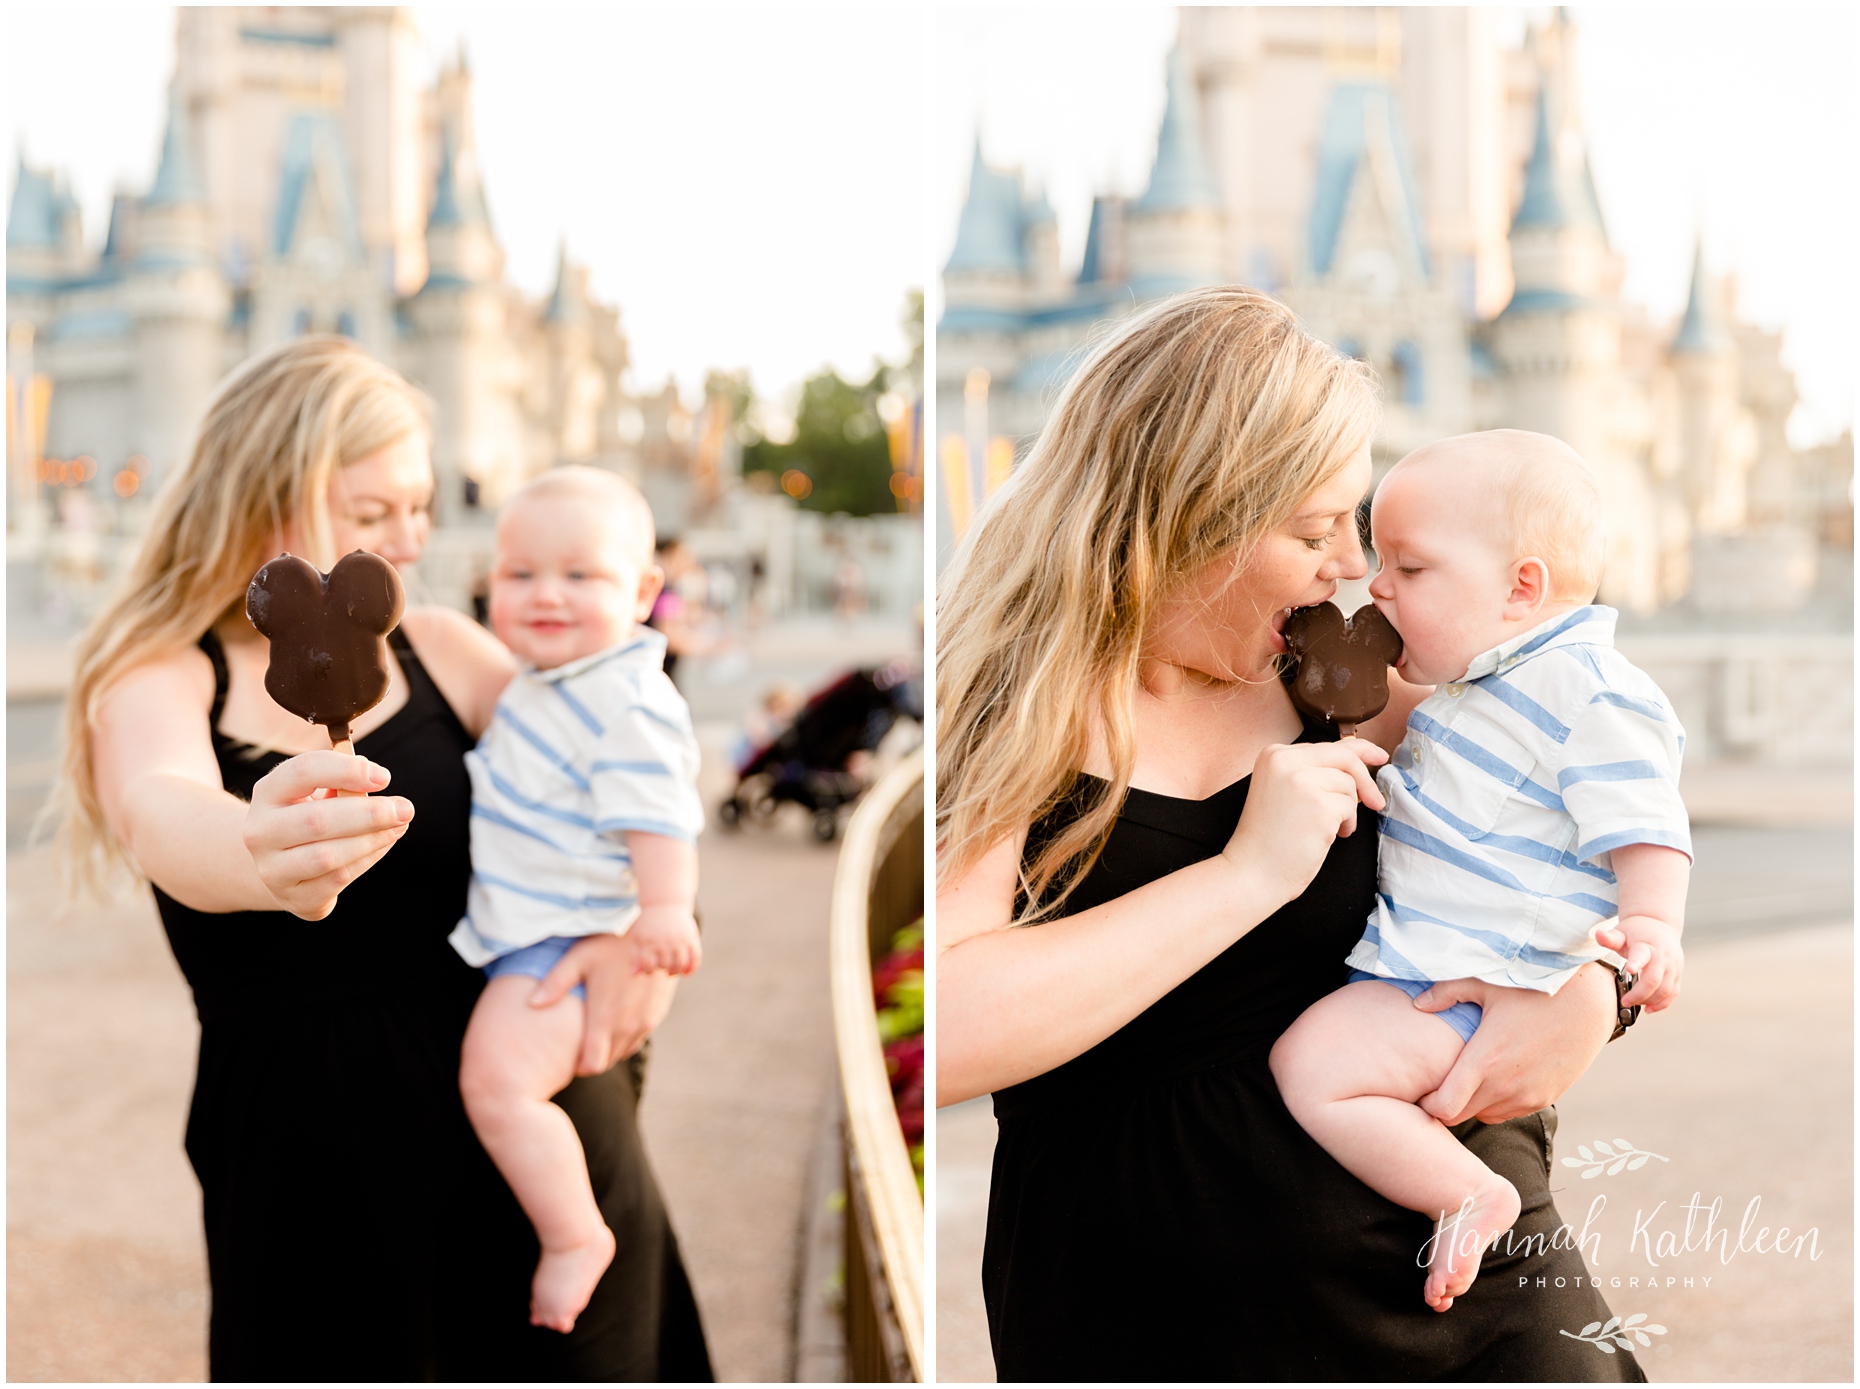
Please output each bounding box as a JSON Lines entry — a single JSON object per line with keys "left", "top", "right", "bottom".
{"left": 60, "top": 337, "right": 709, "bottom": 1380}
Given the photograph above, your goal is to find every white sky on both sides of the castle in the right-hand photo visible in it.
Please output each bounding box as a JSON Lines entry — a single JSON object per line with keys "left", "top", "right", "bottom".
{"left": 932, "top": 4, "right": 1860, "bottom": 444}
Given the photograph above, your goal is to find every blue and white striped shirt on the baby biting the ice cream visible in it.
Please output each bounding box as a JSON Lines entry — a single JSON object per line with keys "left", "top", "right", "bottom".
{"left": 1349, "top": 606, "right": 1693, "bottom": 993}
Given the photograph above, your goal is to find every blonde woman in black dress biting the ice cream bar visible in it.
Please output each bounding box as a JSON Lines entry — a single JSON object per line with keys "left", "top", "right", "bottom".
{"left": 936, "top": 288, "right": 1642, "bottom": 1382}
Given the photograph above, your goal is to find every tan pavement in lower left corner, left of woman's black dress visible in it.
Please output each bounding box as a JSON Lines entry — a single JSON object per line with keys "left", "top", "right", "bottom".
{"left": 6, "top": 852, "right": 206, "bottom": 1380}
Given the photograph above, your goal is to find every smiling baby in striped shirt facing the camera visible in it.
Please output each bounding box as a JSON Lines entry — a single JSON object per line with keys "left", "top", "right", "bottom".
{"left": 452, "top": 467, "right": 703, "bottom": 1331}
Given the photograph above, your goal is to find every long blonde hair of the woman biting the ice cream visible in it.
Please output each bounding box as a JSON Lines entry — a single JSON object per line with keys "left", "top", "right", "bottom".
{"left": 936, "top": 286, "right": 1376, "bottom": 924}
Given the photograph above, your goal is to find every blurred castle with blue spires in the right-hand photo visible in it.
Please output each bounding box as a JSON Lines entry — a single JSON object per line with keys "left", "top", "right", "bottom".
{"left": 937, "top": 7, "right": 1853, "bottom": 628}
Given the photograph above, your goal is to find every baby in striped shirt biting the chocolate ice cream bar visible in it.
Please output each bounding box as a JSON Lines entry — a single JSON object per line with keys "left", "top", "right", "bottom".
{"left": 1272, "top": 430, "right": 1691, "bottom": 1311}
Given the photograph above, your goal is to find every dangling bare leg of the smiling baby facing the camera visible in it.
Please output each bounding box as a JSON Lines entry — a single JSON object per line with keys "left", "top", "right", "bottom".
{"left": 459, "top": 974, "right": 614, "bottom": 1331}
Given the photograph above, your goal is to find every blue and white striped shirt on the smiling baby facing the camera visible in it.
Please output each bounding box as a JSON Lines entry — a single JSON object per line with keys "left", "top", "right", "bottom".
{"left": 450, "top": 628, "right": 703, "bottom": 965}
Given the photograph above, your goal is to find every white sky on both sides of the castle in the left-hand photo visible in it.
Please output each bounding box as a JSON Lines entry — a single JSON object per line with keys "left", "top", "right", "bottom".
{"left": 0, "top": 4, "right": 930, "bottom": 407}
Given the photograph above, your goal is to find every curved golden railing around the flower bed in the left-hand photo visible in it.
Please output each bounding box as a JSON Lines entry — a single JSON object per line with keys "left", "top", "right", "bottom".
{"left": 830, "top": 751, "right": 924, "bottom": 1382}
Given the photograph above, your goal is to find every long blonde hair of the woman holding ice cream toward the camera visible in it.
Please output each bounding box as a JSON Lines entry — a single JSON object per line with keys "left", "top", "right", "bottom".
{"left": 47, "top": 337, "right": 430, "bottom": 887}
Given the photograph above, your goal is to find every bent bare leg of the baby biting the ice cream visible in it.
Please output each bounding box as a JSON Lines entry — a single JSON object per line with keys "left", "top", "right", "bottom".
{"left": 1272, "top": 980, "right": 1518, "bottom": 1311}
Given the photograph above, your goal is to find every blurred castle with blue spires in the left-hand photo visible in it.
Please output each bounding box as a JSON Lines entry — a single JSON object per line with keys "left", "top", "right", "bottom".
{"left": 6, "top": 6, "right": 725, "bottom": 550}
